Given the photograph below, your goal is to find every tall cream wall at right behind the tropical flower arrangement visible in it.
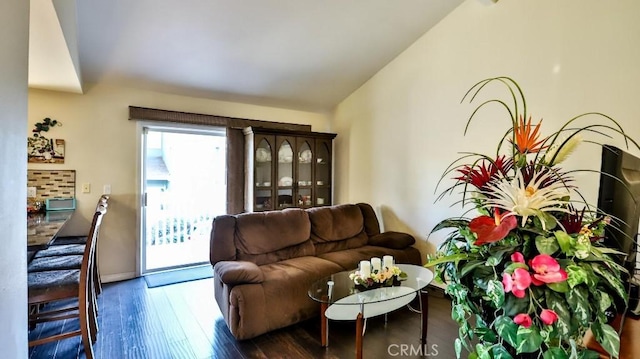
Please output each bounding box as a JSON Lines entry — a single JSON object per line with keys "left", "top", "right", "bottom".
{"left": 332, "top": 0, "right": 640, "bottom": 253}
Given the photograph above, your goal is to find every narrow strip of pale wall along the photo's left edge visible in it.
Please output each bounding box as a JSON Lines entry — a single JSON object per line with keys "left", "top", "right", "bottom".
{"left": 0, "top": 0, "right": 29, "bottom": 359}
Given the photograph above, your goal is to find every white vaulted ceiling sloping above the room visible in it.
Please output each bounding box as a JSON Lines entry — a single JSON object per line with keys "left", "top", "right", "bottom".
{"left": 29, "top": 0, "right": 463, "bottom": 111}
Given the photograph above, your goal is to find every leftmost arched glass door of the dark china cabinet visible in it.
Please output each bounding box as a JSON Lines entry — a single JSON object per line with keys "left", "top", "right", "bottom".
{"left": 254, "top": 138, "right": 273, "bottom": 211}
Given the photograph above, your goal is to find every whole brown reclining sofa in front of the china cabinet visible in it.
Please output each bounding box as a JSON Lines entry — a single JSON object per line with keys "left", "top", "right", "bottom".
{"left": 210, "top": 203, "right": 422, "bottom": 339}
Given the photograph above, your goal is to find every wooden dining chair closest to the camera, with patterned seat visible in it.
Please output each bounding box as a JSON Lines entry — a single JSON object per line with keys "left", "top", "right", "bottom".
{"left": 28, "top": 207, "right": 107, "bottom": 359}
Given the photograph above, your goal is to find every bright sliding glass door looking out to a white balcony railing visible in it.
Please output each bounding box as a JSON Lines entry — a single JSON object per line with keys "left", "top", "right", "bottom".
{"left": 140, "top": 126, "right": 226, "bottom": 274}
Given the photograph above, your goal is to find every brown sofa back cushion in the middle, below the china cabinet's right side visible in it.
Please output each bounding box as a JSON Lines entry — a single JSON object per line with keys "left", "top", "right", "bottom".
{"left": 307, "top": 204, "right": 368, "bottom": 254}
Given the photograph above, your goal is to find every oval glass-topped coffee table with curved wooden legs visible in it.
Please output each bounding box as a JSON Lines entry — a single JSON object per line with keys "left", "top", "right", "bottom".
{"left": 309, "top": 264, "right": 433, "bottom": 359}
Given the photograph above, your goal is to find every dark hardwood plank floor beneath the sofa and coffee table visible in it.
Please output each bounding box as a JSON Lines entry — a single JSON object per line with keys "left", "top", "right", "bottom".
{"left": 29, "top": 278, "right": 458, "bottom": 359}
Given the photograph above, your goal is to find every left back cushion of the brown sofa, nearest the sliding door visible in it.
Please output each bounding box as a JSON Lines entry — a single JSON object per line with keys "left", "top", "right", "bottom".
{"left": 234, "top": 208, "right": 315, "bottom": 265}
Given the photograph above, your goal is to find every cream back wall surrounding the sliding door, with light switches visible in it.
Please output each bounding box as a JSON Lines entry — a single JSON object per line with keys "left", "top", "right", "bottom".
{"left": 27, "top": 84, "right": 329, "bottom": 281}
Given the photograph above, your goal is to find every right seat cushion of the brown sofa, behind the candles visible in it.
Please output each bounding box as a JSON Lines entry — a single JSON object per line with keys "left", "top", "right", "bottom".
{"left": 318, "top": 245, "right": 422, "bottom": 270}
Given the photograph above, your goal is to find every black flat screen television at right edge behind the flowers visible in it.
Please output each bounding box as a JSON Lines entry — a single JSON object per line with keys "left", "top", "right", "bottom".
{"left": 598, "top": 145, "right": 640, "bottom": 275}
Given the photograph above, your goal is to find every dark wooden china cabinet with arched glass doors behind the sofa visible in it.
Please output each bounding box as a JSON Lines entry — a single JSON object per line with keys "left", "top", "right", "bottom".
{"left": 244, "top": 127, "right": 336, "bottom": 212}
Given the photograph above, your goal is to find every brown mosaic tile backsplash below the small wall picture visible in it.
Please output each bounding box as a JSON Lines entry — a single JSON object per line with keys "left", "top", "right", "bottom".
{"left": 27, "top": 170, "right": 76, "bottom": 199}
